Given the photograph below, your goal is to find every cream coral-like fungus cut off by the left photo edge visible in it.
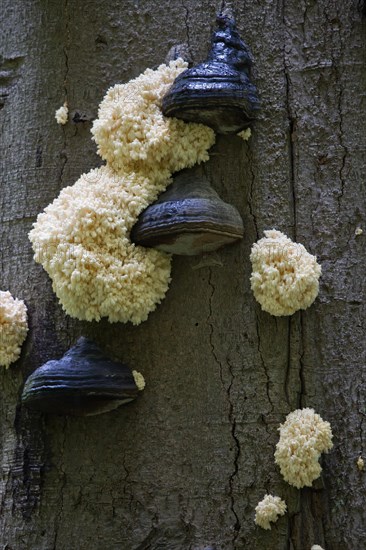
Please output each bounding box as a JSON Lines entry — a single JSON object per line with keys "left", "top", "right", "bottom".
{"left": 0, "top": 291, "right": 28, "bottom": 367}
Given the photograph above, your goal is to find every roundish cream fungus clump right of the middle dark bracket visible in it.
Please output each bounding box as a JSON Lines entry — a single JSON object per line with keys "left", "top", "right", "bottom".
{"left": 250, "top": 229, "right": 321, "bottom": 316}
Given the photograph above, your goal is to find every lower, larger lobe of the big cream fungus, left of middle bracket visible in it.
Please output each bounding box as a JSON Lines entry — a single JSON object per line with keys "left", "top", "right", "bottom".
{"left": 30, "top": 166, "right": 170, "bottom": 324}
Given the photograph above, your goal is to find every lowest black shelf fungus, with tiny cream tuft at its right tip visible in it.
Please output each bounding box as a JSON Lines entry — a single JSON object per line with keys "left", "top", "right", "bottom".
{"left": 22, "top": 337, "right": 145, "bottom": 416}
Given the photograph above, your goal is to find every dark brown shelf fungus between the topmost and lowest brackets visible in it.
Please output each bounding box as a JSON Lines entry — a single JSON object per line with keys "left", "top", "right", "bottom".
{"left": 131, "top": 167, "right": 244, "bottom": 255}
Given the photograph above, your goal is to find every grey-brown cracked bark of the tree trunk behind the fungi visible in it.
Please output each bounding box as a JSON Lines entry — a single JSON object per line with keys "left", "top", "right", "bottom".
{"left": 0, "top": 0, "right": 366, "bottom": 550}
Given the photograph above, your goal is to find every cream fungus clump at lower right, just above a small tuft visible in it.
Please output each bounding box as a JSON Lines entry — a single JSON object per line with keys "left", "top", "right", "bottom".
{"left": 274, "top": 408, "right": 333, "bottom": 489}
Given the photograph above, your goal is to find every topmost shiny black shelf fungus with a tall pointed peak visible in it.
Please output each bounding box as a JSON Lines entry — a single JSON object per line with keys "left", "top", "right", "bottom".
{"left": 162, "top": 9, "right": 259, "bottom": 134}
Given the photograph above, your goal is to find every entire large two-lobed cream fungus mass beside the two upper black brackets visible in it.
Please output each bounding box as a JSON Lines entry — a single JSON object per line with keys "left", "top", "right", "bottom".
{"left": 29, "top": 60, "right": 215, "bottom": 324}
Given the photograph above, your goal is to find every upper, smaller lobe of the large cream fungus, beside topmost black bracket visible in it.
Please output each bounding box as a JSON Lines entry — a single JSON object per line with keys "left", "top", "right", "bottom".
{"left": 92, "top": 59, "right": 215, "bottom": 181}
